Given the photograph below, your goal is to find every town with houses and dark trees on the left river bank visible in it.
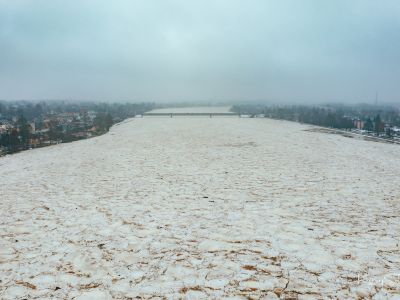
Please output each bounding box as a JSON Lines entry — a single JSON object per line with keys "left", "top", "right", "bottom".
{"left": 0, "top": 101, "right": 154, "bottom": 156}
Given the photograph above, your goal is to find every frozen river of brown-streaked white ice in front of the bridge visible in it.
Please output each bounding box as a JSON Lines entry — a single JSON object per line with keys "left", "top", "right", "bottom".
{"left": 0, "top": 108, "right": 400, "bottom": 299}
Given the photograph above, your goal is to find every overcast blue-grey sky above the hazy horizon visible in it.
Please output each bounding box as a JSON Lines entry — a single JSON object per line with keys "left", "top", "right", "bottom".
{"left": 0, "top": 0, "right": 400, "bottom": 102}
